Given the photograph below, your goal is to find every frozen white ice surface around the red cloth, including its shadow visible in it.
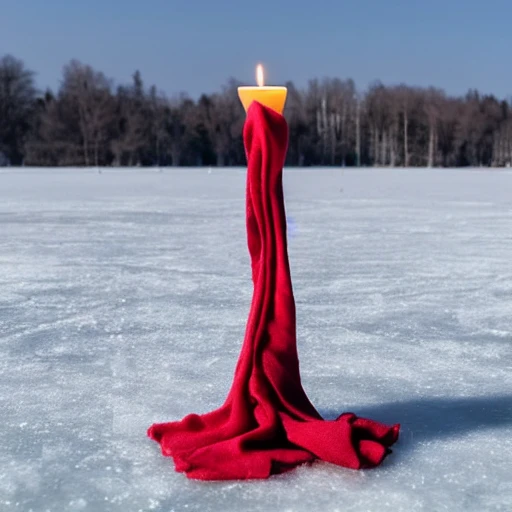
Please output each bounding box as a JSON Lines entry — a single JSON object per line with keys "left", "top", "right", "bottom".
{"left": 0, "top": 169, "right": 512, "bottom": 512}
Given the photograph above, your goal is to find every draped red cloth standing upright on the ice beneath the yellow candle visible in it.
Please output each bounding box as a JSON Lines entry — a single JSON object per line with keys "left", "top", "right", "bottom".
{"left": 148, "top": 102, "right": 400, "bottom": 480}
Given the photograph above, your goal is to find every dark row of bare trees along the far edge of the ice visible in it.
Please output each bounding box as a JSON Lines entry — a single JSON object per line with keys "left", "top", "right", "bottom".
{"left": 0, "top": 55, "right": 512, "bottom": 167}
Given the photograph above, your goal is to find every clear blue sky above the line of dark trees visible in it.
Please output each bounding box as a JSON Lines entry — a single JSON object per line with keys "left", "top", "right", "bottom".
{"left": 0, "top": 0, "right": 512, "bottom": 98}
